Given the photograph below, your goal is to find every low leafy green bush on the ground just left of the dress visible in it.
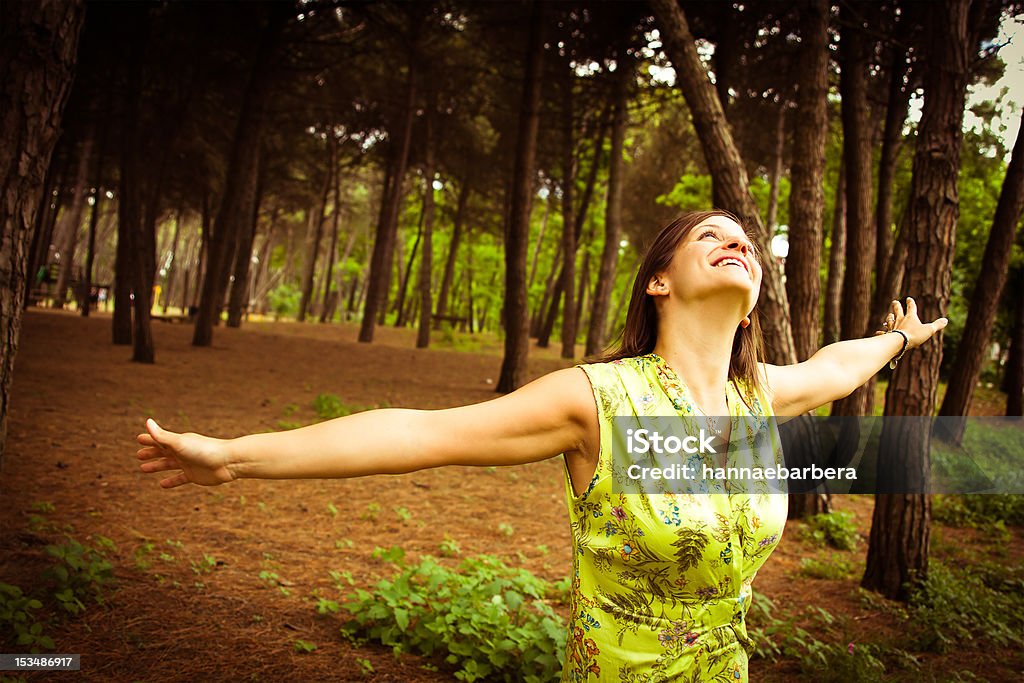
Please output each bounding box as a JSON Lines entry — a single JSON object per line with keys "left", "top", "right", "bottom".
{"left": 331, "top": 552, "right": 565, "bottom": 682}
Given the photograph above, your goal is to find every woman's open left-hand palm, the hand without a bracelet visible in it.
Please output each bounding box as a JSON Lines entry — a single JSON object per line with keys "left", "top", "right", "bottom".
{"left": 137, "top": 419, "right": 236, "bottom": 488}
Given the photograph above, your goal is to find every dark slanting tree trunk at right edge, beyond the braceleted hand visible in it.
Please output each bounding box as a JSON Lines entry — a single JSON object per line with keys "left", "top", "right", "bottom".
{"left": 939, "top": 113, "right": 1024, "bottom": 438}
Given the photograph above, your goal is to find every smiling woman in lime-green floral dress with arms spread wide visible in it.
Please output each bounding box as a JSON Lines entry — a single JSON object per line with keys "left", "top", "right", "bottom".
{"left": 138, "top": 211, "right": 946, "bottom": 681}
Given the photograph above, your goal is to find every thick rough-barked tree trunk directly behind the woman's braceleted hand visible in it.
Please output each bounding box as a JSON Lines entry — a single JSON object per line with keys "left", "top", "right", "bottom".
{"left": 861, "top": 0, "right": 976, "bottom": 600}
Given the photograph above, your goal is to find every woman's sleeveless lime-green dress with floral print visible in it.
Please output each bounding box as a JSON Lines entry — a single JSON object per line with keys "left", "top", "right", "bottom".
{"left": 562, "top": 353, "right": 787, "bottom": 683}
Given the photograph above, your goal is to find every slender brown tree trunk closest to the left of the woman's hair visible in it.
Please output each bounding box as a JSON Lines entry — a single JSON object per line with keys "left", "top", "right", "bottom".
{"left": 586, "top": 63, "right": 633, "bottom": 355}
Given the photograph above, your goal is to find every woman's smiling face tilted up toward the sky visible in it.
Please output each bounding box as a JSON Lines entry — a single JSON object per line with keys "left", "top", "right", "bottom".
{"left": 648, "top": 216, "right": 762, "bottom": 315}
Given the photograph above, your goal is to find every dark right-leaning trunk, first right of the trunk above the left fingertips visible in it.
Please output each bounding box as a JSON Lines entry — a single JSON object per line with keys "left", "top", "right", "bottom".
{"left": 193, "top": 3, "right": 293, "bottom": 346}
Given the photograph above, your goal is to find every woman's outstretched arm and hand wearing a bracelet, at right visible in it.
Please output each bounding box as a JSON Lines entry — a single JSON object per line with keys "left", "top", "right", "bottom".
{"left": 764, "top": 297, "right": 947, "bottom": 416}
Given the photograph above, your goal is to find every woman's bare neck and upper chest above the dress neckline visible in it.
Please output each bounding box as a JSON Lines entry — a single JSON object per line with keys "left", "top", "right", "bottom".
{"left": 654, "top": 305, "right": 736, "bottom": 416}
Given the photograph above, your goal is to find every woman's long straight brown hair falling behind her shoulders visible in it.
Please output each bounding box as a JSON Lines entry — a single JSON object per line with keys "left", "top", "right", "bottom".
{"left": 592, "top": 209, "right": 764, "bottom": 401}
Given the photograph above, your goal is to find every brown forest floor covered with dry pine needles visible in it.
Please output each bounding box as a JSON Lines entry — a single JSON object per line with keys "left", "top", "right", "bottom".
{"left": 0, "top": 309, "right": 1024, "bottom": 681}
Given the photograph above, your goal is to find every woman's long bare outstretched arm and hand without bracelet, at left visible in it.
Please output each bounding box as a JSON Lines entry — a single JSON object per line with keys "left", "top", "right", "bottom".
{"left": 137, "top": 368, "right": 598, "bottom": 488}
